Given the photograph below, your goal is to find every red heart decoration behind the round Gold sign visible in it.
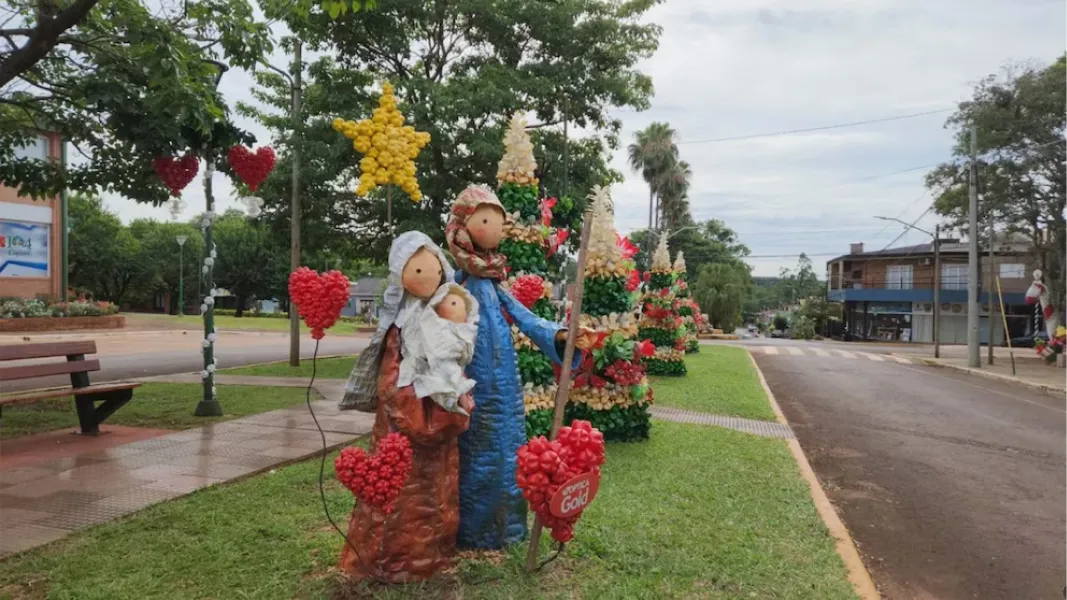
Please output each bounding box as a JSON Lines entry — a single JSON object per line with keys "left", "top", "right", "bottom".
{"left": 515, "top": 420, "right": 604, "bottom": 543}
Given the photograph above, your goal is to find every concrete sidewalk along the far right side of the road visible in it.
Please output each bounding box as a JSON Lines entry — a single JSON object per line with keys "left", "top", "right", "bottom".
{"left": 894, "top": 348, "right": 1067, "bottom": 398}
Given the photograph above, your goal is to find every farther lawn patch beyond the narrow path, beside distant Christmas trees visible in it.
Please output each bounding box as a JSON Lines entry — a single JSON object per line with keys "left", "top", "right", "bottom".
{"left": 651, "top": 346, "right": 775, "bottom": 421}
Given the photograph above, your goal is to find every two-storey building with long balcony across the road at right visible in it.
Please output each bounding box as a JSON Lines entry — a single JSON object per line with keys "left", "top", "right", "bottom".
{"left": 826, "top": 239, "right": 1034, "bottom": 345}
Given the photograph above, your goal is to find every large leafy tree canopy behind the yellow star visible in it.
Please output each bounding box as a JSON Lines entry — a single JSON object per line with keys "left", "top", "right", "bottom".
{"left": 242, "top": 0, "right": 659, "bottom": 260}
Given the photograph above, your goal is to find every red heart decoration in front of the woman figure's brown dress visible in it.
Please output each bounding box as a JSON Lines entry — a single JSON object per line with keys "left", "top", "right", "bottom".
{"left": 334, "top": 431, "right": 414, "bottom": 515}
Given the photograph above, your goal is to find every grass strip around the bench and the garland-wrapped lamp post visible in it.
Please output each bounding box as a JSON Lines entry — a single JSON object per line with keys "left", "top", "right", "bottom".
{"left": 0, "top": 383, "right": 305, "bottom": 440}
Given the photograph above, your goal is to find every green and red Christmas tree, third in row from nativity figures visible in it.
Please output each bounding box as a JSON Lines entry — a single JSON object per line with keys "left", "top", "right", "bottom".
{"left": 638, "top": 236, "right": 686, "bottom": 375}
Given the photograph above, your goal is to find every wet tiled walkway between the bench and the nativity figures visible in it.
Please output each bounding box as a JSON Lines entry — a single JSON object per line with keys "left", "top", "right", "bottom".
{"left": 0, "top": 376, "right": 373, "bottom": 556}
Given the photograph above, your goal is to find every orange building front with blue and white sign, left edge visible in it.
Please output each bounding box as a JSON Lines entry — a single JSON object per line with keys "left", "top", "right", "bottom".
{"left": 0, "top": 132, "right": 65, "bottom": 299}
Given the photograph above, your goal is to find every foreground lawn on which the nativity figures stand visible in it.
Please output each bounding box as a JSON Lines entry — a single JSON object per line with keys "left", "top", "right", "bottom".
{"left": 0, "top": 423, "right": 855, "bottom": 600}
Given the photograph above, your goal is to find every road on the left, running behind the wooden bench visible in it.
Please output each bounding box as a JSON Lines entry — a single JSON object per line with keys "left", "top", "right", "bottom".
{"left": 2, "top": 331, "right": 369, "bottom": 392}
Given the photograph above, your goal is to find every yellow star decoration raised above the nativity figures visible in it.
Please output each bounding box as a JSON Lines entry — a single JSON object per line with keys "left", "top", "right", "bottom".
{"left": 333, "top": 83, "right": 430, "bottom": 202}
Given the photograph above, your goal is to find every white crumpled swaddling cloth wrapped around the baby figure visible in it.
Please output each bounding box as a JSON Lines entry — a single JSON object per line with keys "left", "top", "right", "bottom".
{"left": 397, "top": 283, "right": 478, "bottom": 414}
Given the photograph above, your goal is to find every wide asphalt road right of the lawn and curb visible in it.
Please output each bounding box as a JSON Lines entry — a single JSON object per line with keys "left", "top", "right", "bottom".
{"left": 754, "top": 348, "right": 1067, "bottom": 600}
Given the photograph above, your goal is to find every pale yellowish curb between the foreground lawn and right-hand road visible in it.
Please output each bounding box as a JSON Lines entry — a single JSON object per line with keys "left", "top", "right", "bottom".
{"left": 748, "top": 351, "right": 881, "bottom": 600}
